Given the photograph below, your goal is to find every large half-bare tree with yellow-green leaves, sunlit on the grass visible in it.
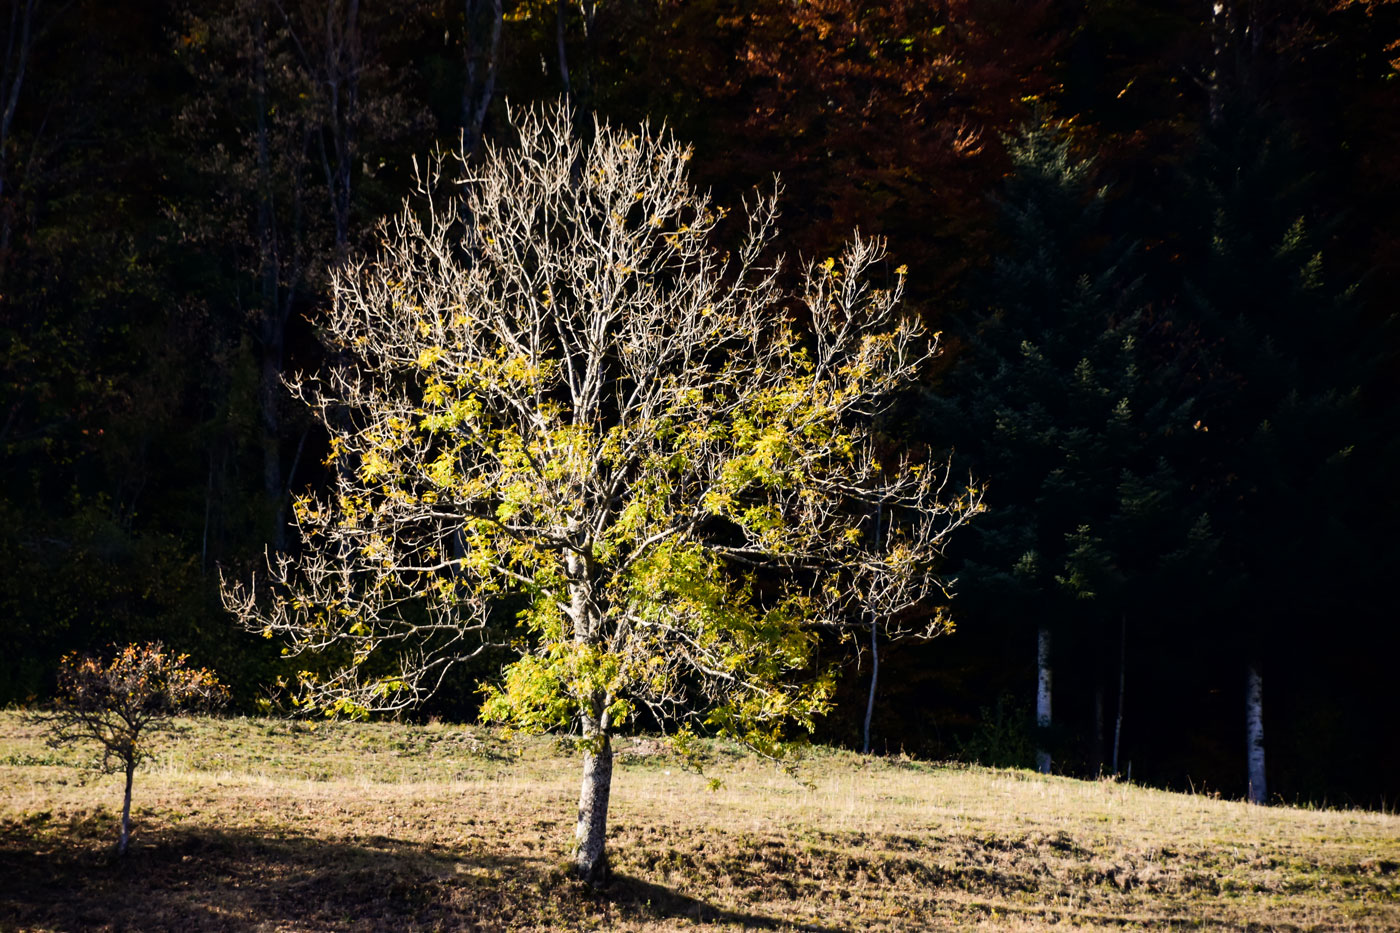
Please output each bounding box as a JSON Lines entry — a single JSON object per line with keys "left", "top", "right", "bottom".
{"left": 225, "top": 106, "right": 977, "bottom": 883}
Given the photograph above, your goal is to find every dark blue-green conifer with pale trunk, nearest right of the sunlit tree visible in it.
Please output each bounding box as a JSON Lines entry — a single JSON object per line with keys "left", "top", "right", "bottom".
{"left": 928, "top": 119, "right": 1186, "bottom": 772}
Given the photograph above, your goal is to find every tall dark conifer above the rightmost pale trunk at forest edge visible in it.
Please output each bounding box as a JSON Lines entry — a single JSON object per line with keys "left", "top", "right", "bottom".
{"left": 1186, "top": 94, "right": 1378, "bottom": 803}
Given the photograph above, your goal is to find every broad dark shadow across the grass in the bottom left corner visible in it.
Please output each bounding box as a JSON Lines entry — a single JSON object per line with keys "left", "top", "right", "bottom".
{"left": 0, "top": 814, "right": 825, "bottom": 933}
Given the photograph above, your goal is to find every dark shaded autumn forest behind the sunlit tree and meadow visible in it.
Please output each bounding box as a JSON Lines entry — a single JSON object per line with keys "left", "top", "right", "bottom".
{"left": 0, "top": 0, "right": 1400, "bottom": 803}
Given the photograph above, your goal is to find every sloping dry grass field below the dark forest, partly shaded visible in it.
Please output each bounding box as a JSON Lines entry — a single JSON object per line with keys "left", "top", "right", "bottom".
{"left": 0, "top": 712, "right": 1400, "bottom": 933}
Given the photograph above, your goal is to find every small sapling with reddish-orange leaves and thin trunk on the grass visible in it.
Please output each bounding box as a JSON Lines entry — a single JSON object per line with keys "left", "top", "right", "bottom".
{"left": 38, "top": 643, "right": 227, "bottom": 856}
